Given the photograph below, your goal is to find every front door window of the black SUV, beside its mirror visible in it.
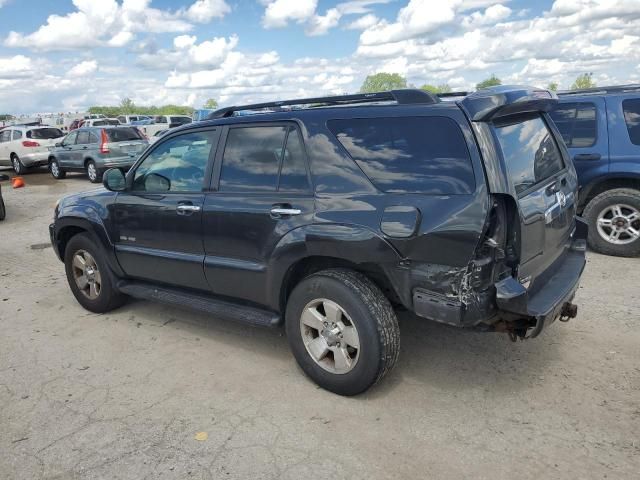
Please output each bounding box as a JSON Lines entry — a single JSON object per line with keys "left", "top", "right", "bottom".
{"left": 133, "top": 130, "right": 216, "bottom": 193}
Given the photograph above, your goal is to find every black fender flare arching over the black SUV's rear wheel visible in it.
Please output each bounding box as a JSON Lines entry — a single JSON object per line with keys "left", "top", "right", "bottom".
{"left": 267, "top": 224, "right": 402, "bottom": 310}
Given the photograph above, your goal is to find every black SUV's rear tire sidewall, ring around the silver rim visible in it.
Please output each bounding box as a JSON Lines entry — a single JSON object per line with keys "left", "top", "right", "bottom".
{"left": 285, "top": 274, "right": 382, "bottom": 395}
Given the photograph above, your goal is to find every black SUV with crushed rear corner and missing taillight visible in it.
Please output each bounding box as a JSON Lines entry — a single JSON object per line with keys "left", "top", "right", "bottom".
{"left": 50, "top": 87, "right": 587, "bottom": 395}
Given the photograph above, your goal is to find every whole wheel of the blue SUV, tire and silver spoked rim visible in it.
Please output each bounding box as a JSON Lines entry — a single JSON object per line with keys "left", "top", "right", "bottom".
{"left": 583, "top": 188, "right": 640, "bottom": 257}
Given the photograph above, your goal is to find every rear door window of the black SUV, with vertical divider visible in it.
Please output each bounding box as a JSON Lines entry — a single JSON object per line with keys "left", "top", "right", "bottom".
{"left": 220, "top": 126, "right": 309, "bottom": 192}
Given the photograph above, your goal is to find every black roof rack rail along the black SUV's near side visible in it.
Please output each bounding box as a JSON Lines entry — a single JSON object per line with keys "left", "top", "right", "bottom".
{"left": 207, "top": 88, "right": 440, "bottom": 120}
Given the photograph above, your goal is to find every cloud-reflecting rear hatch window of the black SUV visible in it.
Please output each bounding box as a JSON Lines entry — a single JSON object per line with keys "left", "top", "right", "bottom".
{"left": 495, "top": 115, "right": 564, "bottom": 193}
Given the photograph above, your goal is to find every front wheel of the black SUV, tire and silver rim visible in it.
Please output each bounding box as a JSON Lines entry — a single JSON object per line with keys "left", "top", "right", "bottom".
{"left": 64, "top": 233, "right": 126, "bottom": 313}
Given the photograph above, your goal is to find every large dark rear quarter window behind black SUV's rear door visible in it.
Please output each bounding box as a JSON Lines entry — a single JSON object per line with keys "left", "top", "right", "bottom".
{"left": 328, "top": 117, "right": 475, "bottom": 195}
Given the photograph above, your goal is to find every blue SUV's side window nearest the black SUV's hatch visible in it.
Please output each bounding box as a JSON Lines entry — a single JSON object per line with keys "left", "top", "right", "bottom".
{"left": 550, "top": 102, "right": 597, "bottom": 148}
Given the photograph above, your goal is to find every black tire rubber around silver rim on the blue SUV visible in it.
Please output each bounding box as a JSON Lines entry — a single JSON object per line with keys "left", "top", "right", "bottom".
{"left": 584, "top": 190, "right": 640, "bottom": 257}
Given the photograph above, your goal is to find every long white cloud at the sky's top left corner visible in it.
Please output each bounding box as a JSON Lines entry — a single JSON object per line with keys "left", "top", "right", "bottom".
{"left": 4, "top": 0, "right": 230, "bottom": 50}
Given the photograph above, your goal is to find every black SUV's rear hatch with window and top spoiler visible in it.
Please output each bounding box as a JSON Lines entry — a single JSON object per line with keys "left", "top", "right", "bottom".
{"left": 461, "top": 91, "right": 578, "bottom": 293}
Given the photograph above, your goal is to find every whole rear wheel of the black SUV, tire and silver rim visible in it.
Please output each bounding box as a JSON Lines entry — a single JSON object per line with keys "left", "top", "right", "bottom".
{"left": 285, "top": 269, "right": 400, "bottom": 396}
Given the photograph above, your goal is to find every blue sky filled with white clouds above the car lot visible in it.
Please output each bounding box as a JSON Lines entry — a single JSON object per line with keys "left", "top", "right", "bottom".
{"left": 0, "top": 0, "right": 640, "bottom": 114}
